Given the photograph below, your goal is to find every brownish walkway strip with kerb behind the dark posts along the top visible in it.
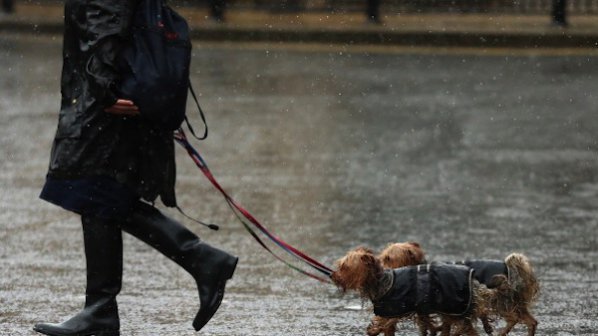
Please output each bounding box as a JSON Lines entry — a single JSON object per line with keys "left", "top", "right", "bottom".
{"left": 0, "top": 3, "right": 598, "bottom": 48}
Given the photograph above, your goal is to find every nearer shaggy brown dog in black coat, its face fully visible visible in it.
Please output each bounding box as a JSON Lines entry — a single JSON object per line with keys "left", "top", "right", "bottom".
{"left": 331, "top": 247, "right": 488, "bottom": 336}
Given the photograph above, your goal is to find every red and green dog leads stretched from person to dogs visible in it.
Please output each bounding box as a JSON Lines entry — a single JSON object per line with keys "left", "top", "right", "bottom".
{"left": 174, "top": 128, "right": 333, "bottom": 283}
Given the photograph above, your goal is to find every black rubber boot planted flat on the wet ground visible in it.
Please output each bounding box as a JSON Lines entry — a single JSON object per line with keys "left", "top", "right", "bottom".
{"left": 33, "top": 216, "right": 122, "bottom": 336}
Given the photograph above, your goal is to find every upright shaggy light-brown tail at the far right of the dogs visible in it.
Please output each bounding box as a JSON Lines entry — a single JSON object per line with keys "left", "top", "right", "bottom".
{"left": 505, "top": 253, "right": 540, "bottom": 304}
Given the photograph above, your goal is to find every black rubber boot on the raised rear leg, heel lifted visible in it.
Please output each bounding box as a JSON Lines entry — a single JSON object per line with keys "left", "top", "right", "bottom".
{"left": 122, "top": 202, "right": 238, "bottom": 330}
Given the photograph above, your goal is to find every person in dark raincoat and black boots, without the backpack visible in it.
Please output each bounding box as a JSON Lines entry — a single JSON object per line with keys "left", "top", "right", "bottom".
{"left": 33, "top": 0, "right": 238, "bottom": 336}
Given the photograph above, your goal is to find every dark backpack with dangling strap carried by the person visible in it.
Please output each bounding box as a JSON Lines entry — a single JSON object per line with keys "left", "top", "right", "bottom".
{"left": 118, "top": 0, "right": 207, "bottom": 138}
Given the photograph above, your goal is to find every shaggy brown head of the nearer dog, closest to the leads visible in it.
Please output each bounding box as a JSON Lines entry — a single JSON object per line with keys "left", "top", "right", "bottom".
{"left": 331, "top": 247, "right": 384, "bottom": 295}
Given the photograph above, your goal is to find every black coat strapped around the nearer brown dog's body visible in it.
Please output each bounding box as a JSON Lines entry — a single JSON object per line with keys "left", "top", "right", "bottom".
{"left": 372, "top": 263, "right": 473, "bottom": 317}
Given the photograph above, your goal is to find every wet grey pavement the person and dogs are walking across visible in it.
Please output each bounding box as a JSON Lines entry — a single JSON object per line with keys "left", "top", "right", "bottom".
{"left": 0, "top": 35, "right": 598, "bottom": 336}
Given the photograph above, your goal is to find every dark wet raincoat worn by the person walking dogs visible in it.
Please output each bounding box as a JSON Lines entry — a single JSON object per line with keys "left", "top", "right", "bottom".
{"left": 48, "top": 0, "right": 176, "bottom": 206}
